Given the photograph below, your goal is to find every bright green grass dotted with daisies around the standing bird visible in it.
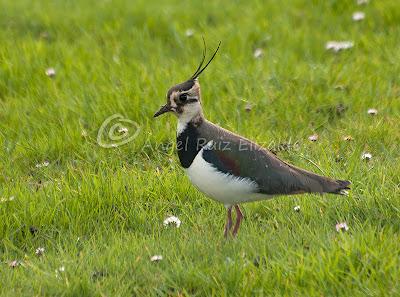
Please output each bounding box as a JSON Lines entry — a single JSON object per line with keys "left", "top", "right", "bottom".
{"left": 0, "top": 0, "right": 400, "bottom": 296}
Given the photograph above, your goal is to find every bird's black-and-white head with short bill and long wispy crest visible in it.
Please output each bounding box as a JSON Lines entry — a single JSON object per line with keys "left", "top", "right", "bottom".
{"left": 154, "top": 40, "right": 221, "bottom": 121}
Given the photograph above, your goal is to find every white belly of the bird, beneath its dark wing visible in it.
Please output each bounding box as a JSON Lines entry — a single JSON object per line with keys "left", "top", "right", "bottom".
{"left": 186, "top": 149, "right": 270, "bottom": 206}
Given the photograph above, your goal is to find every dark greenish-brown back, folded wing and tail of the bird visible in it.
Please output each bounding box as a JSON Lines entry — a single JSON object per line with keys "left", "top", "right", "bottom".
{"left": 195, "top": 120, "right": 350, "bottom": 195}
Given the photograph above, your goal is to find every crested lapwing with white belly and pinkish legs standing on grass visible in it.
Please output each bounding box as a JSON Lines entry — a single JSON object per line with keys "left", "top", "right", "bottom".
{"left": 154, "top": 39, "right": 351, "bottom": 237}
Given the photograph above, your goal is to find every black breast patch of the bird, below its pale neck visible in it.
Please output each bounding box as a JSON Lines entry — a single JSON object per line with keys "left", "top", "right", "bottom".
{"left": 176, "top": 122, "right": 203, "bottom": 168}
